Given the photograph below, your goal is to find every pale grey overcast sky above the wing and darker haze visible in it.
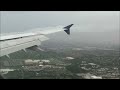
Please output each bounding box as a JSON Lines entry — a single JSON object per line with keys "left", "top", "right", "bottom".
{"left": 0, "top": 11, "right": 120, "bottom": 33}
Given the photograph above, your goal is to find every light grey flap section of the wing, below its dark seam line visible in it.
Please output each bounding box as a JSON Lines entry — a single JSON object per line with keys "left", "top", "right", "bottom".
{"left": 0, "top": 35, "right": 48, "bottom": 56}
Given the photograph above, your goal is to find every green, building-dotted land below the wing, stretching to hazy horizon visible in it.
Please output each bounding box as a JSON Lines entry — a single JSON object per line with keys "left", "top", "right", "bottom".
{"left": 1, "top": 32, "right": 120, "bottom": 79}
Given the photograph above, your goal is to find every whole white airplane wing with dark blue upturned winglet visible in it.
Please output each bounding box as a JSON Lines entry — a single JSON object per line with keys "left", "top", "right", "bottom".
{"left": 0, "top": 24, "right": 73, "bottom": 57}
